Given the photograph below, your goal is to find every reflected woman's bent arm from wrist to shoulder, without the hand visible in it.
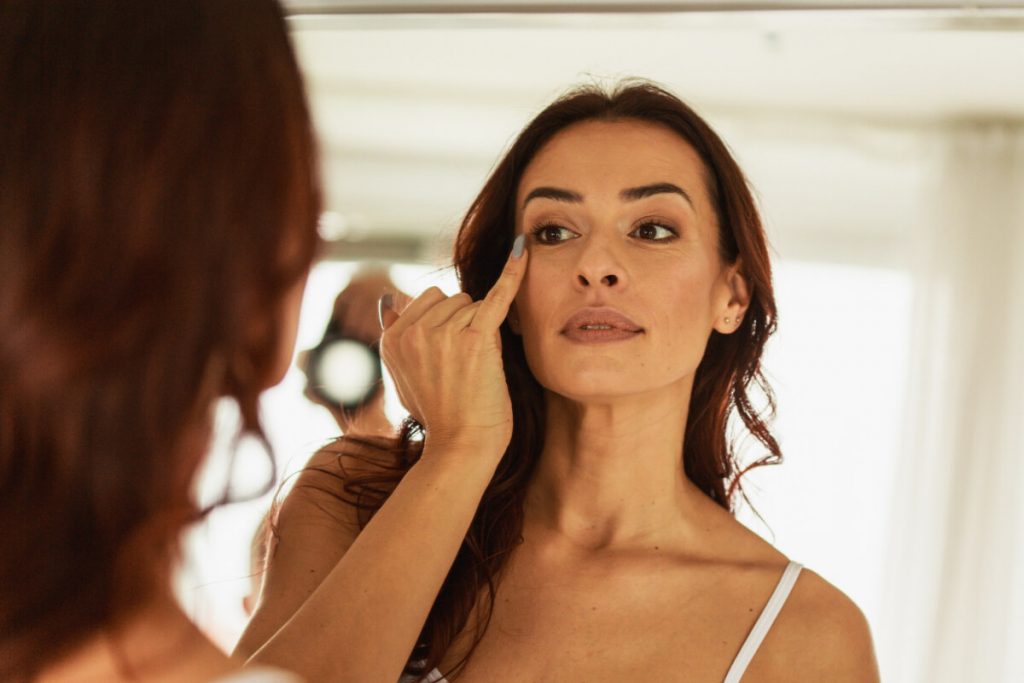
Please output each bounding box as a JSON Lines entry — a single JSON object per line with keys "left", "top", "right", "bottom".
{"left": 237, "top": 443, "right": 501, "bottom": 682}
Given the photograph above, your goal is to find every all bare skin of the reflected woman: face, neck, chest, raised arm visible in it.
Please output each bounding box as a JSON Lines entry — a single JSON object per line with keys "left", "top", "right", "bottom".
{"left": 237, "top": 122, "right": 878, "bottom": 683}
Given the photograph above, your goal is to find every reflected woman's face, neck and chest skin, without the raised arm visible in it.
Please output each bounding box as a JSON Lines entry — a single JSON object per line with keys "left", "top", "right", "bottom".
{"left": 432, "top": 122, "right": 878, "bottom": 683}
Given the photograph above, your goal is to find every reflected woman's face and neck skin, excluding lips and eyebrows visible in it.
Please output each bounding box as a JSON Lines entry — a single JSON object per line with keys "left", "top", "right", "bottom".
{"left": 515, "top": 118, "right": 750, "bottom": 547}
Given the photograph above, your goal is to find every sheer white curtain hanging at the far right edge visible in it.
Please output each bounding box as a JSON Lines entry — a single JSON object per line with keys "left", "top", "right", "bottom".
{"left": 878, "top": 123, "right": 1024, "bottom": 683}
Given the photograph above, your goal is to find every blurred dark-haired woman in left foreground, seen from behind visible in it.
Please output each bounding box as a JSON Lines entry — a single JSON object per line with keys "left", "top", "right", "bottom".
{"left": 0, "top": 0, "right": 319, "bottom": 683}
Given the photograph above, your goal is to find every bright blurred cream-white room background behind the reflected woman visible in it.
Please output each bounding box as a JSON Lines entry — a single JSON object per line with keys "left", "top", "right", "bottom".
{"left": 177, "top": 0, "right": 1024, "bottom": 682}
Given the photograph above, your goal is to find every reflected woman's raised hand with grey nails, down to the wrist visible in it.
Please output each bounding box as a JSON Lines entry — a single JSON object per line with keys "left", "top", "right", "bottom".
{"left": 381, "top": 236, "right": 528, "bottom": 455}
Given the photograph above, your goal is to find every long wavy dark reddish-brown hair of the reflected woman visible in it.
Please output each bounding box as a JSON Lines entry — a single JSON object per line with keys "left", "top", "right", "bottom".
{"left": 338, "top": 81, "right": 781, "bottom": 676}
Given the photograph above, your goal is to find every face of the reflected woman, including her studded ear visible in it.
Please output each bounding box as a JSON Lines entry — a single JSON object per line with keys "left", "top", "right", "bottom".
{"left": 510, "top": 120, "right": 746, "bottom": 400}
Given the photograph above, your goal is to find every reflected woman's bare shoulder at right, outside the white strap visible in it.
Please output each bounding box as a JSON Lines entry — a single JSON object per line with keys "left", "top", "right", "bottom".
{"left": 751, "top": 568, "right": 879, "bottom": 683}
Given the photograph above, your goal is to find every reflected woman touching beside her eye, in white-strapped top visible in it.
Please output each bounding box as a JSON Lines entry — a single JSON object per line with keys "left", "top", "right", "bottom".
{"left": 239, "top": 83, "right": 878, "bottom": 682}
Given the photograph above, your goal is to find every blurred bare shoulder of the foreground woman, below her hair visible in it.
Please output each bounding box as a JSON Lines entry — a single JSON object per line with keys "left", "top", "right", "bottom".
{"left": 39, "top": 593, "right": 238, "bottom": 683}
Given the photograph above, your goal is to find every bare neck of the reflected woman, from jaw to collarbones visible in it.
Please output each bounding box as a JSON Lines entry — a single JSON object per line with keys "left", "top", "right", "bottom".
{"left": 524, "top": 382, "right": 708, "bottom": 550}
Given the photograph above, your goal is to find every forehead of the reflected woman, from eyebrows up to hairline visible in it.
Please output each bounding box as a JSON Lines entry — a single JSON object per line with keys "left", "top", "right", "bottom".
{"left": 516, "top": 120, "right": 709, "bottom": 210}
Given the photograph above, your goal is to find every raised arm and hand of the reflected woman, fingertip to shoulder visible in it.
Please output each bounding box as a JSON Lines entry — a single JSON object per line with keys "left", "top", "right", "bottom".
{"left": 238, "top": 236, "right": 528, "bottom": 683}
